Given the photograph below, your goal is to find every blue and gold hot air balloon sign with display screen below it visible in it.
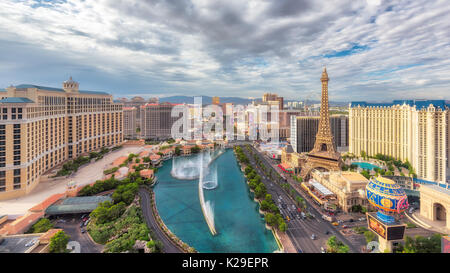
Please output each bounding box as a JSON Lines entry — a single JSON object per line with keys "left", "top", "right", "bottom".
{"left": 366, "top": 176, "right": 408, "bottom": 251}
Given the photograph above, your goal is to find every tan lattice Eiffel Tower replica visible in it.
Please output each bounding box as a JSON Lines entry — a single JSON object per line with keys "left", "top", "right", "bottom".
{"left": 300, "top": 68, "right": 342, "bottom": 179}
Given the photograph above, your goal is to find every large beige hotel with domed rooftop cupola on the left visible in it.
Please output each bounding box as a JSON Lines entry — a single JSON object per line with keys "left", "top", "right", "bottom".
{"left": 0, "top": 78, "right": 123, "bottom": 200}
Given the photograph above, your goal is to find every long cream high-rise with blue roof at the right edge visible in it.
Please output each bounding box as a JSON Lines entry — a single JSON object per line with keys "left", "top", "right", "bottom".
{"left": 349, "top": 100, "right": 450, "bottom": 182}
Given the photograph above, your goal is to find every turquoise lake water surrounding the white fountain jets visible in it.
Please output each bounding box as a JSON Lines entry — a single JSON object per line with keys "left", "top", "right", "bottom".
{"left": 154, "top": 149, "right": 278, "bottom": 253}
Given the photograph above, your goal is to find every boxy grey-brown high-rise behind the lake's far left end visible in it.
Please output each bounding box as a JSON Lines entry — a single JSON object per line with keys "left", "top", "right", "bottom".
{"left": 140, "top": 102, "right": 179, "bottom": 139}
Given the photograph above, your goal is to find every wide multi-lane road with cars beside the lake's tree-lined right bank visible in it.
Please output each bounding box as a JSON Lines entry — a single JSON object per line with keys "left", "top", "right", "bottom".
{"left": 243, "top": 145, "right": 359, "bottom": 253}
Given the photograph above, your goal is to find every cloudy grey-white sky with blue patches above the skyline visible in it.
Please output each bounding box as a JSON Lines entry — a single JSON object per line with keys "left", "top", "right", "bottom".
{"left": 0, "top": 0, "right": 450, "bottom": 101}
